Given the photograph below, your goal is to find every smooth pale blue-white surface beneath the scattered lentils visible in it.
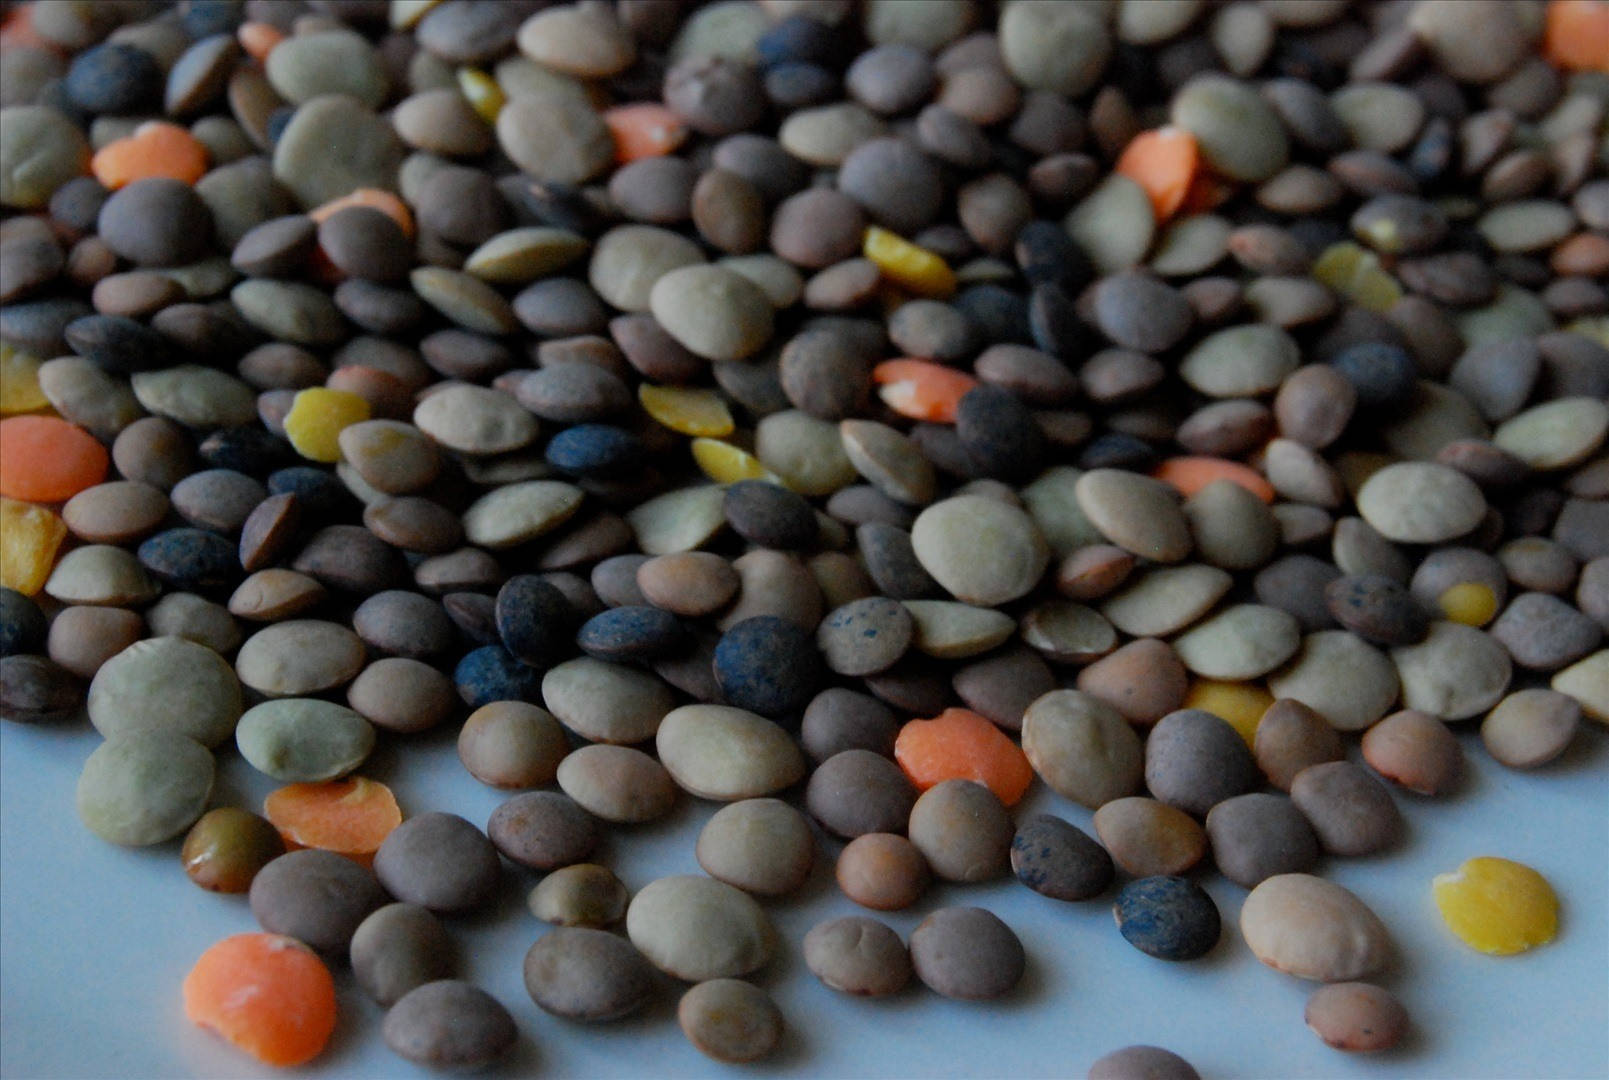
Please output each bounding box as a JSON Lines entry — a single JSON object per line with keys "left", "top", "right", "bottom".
{"left": 0, "top": 704, "right": 1609, "bottom": 1080}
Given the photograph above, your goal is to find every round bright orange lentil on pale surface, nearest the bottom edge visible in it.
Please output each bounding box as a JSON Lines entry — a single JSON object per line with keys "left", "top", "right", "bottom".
{"left": 183, "top": 934, "right": 335, "bottom": 1066}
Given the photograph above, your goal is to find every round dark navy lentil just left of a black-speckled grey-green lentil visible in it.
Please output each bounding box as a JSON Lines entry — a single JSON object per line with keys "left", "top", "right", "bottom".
{"left": 714, "top": 615, "right": 822, "bottom": 716}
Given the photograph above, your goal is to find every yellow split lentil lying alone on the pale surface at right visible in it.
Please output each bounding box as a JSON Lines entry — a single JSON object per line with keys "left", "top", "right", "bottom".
{"left": 1430, "top": 855, "right": 1559, "bottom": 956}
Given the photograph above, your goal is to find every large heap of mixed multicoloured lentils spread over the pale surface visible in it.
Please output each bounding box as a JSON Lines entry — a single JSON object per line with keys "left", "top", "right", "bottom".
{"left": 0, "top": 0, "right": 1609, "bottom": 1077}
